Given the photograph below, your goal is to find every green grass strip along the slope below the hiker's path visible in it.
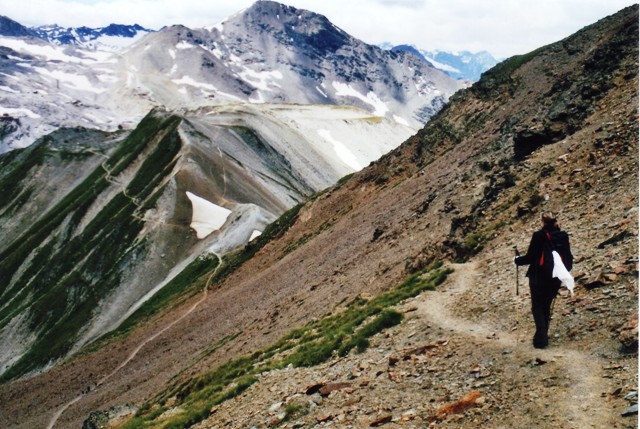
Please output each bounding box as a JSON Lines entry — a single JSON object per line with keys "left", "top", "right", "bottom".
{"left": 125, "top": 264, "right": 452, "bottom": 429}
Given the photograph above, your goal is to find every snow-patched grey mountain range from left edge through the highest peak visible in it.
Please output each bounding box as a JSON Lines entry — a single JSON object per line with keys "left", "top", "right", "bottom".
{"left": 0, "top": 1, "right": 464, "bottom": 153}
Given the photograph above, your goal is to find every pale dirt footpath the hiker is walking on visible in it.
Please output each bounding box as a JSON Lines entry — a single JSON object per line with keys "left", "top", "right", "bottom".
{"left": 417, "top": 262, "right": 614, "bottom": 428}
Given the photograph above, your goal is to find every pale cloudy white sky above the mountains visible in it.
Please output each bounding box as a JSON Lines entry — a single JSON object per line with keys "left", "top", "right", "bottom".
{"left": 0, "top": 0, "right": 637, "bottom": 58}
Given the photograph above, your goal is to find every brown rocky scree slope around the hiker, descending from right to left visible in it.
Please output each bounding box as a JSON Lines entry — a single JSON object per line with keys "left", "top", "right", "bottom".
{"left": 0, "top": 6, "right": 638, "bottom": 427}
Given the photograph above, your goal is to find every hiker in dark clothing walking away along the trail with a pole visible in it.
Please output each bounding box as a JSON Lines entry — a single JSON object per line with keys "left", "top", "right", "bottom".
{"left": 513, "top": 212, "right": 573, "bottom": 349}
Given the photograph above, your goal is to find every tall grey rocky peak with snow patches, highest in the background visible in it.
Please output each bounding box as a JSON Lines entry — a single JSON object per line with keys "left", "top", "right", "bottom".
{"left": 117, "top": 1, "right": 462, "bottom": 127}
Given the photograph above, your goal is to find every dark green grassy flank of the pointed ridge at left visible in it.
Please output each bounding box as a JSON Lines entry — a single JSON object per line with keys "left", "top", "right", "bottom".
{"left": 0, "top": 113, "right": 181, "bottom": 382}
